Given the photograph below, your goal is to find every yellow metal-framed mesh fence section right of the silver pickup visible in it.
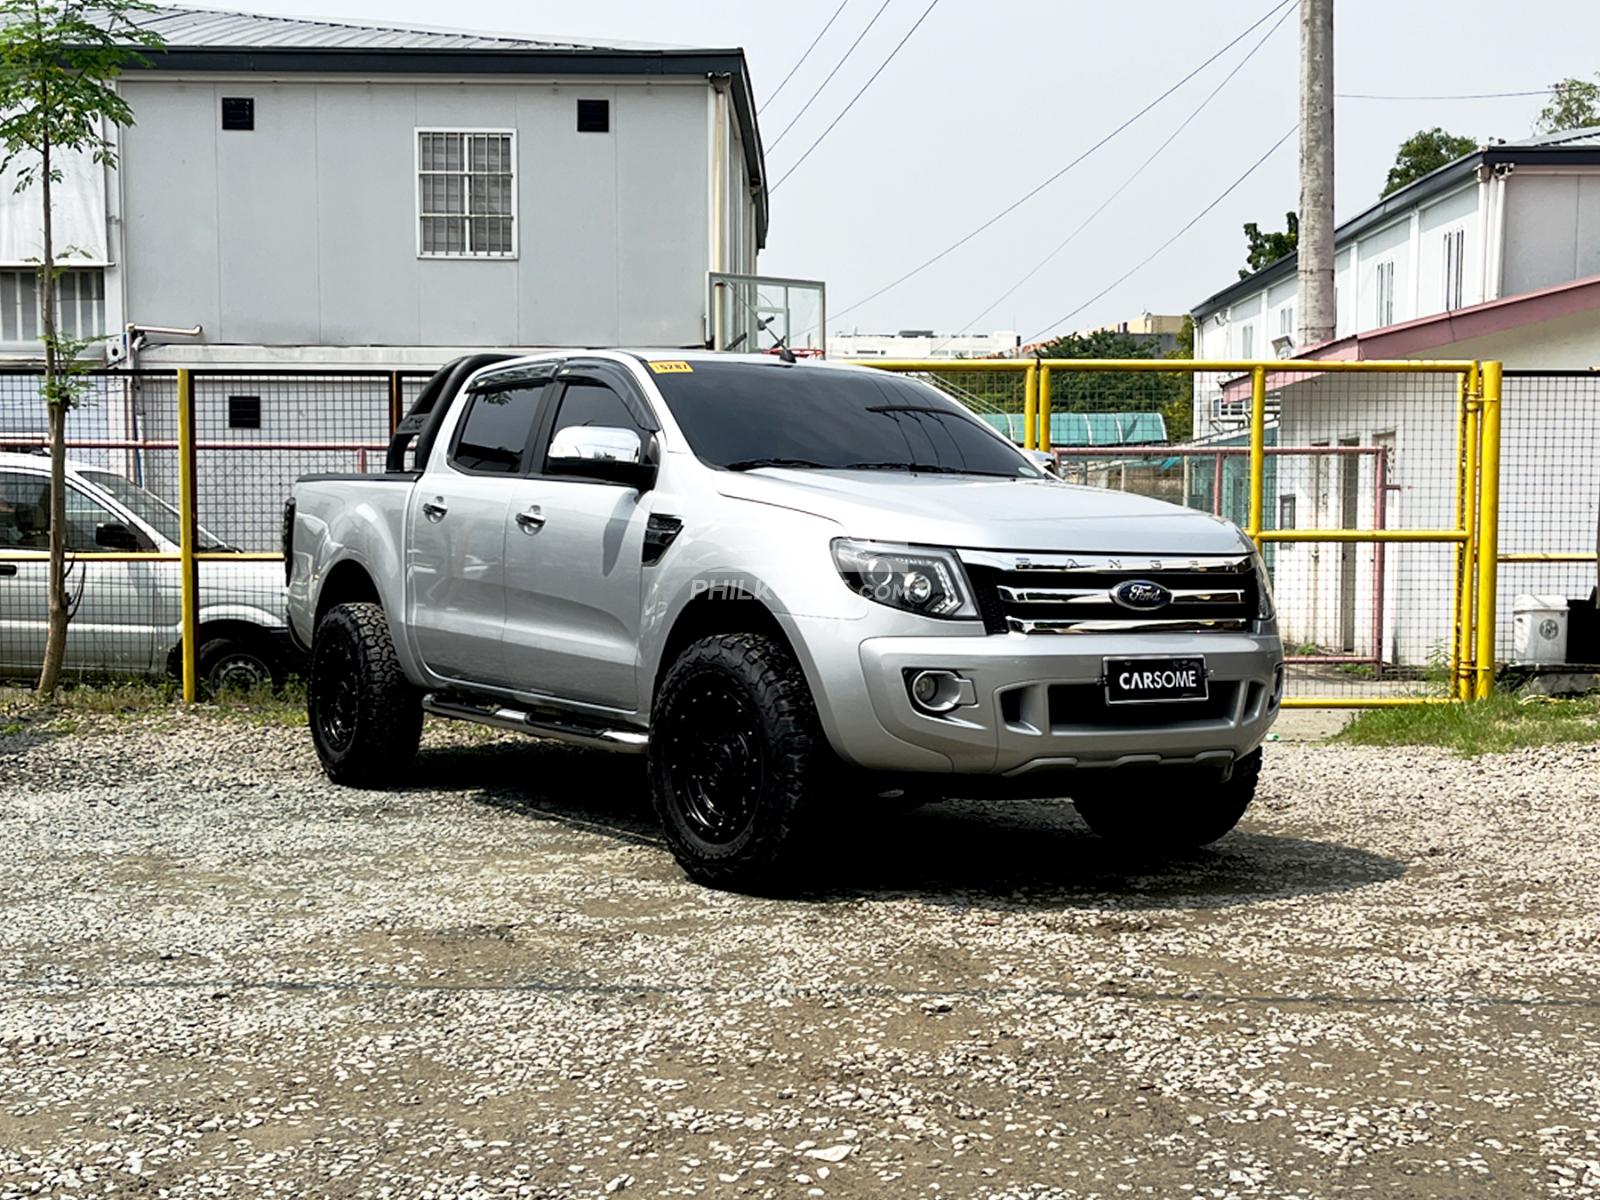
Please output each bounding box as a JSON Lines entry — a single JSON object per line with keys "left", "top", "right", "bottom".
{"left": 859, "top": 358, "right": 1501, "bottom": 709}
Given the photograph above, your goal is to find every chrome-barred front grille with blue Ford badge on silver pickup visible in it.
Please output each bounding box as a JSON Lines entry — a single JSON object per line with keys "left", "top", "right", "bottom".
{"left": 962, "top": 550, "right": 1259, "bottom": 634}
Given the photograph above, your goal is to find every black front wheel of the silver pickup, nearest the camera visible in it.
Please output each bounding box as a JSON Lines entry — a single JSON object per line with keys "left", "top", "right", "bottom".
{"left": 650, "top": 634, "right": 834, "bottom": 893}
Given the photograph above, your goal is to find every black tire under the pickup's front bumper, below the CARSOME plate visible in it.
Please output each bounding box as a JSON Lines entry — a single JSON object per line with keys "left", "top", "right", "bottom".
{"left": 1072, "top": 749, "right": 1261, "bottom": 853}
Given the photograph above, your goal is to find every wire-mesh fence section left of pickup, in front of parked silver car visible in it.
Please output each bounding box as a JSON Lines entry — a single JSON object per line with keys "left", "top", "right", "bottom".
{"left": 0, "top": 370, "right": 427, "bottom": 685}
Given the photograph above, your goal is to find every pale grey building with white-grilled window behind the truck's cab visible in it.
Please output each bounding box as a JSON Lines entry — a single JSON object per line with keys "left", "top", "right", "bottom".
{"left": 0, "top": 6, "right": 766, "bottom": 366}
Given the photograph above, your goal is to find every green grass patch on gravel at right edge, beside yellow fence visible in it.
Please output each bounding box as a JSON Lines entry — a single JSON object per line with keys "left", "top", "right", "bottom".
{"left": 1334, "top": 693, "right": 1600, "bottom": 758}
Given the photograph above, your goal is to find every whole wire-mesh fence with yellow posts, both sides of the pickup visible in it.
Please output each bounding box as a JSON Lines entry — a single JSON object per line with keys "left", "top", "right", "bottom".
{"left": 0, "top": 360, "right": 1529, "bottom": 704}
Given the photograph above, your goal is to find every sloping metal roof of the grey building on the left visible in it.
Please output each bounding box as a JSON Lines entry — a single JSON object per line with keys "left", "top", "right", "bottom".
{"left": 128, "top": 5, "right": 677, "bottom": 50}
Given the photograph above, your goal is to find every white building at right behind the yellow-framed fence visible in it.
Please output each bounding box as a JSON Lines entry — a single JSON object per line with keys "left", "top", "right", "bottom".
{"left": 1194, "top": 130, "right": 1600, "bottom": 678}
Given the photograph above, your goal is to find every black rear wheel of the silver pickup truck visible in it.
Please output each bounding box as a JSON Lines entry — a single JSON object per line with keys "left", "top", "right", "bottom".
{"left": 306, "top": 603, "right": 422, "bottom": 787}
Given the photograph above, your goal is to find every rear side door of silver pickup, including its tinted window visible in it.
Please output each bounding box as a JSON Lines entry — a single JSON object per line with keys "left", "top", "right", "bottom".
{"left": 405, "top": 363, "right": 555, "bottom": 685}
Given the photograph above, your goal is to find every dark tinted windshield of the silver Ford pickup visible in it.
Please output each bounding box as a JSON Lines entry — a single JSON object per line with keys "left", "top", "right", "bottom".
{"left": 656, "top": 360, "right": 1040, "bottom": 478}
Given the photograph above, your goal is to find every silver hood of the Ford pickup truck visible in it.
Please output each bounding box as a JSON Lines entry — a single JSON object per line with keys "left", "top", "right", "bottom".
{"left": 717, "top": 469, "right": 1245, "bottom": 554}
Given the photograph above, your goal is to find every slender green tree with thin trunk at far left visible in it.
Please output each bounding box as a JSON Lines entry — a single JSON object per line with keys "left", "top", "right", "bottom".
{"left": 0, "top": 0, "right": 162, "bottom": 702}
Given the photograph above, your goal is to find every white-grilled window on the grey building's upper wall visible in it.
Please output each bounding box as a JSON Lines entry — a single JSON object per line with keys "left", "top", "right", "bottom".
{"left": 416, "top": 130, "right": 517, "bottom": 258}
